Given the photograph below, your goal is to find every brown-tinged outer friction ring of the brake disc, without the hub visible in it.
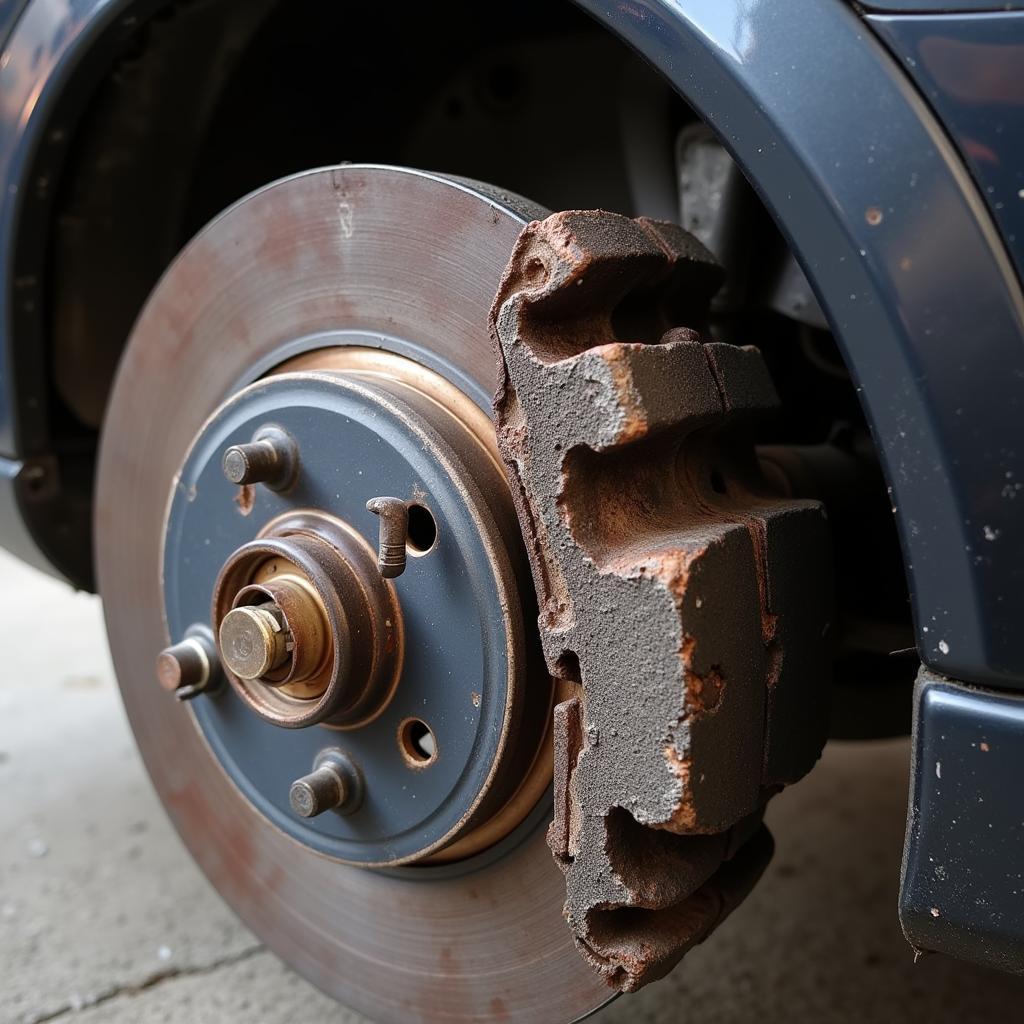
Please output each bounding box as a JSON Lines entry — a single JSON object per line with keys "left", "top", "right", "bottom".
{"left": 95, "top": 165, "right": 610, "bottom": 1022}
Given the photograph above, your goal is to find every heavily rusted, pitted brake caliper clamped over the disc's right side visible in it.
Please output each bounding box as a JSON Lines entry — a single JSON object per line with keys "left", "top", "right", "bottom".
{"left": 492, "top": 212, "right": 831, "bottom": 991}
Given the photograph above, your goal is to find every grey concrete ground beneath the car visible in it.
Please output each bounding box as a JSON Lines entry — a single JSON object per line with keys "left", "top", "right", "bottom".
{"left": 0, "top": 555, "right": 1024, "bottom": 1024}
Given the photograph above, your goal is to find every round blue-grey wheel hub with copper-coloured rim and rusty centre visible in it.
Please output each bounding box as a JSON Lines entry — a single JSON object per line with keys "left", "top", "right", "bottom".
{"left": 163, "top": 346, "right": 551, "bottom": 866}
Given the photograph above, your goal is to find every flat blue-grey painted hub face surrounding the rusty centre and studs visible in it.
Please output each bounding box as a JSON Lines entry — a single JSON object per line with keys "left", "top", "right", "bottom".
{"left": 164, "top": 375, "right": 508, "bottom": 863}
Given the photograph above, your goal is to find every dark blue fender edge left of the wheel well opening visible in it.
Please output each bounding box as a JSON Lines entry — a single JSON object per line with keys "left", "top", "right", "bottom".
{"left": 0, "top": 0, "right": 160, "bottom": 582}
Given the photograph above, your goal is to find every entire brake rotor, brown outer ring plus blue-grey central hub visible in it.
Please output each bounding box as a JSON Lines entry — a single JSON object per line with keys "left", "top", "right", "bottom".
{"left": 95, "top": 166, "right": 609, "bottom": 1021}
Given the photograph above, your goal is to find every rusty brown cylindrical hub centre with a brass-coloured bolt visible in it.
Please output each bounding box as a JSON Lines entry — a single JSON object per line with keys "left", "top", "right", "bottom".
{"left": 212, "top": 507, "right": 402, "bottom": 728}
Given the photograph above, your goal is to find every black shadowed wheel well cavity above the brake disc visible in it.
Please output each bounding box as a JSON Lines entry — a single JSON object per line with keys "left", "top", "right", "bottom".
{"left": 51, "top": 0, "right": 687, "bottom": 440}
